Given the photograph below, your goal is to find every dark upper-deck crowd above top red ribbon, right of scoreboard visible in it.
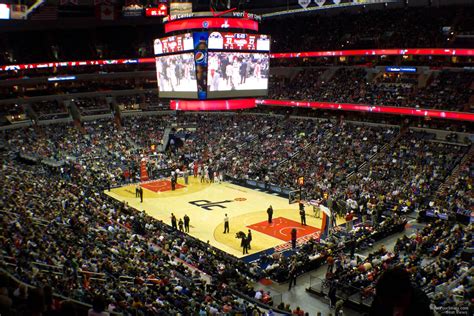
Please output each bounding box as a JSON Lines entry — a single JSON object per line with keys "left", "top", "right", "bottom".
{"left": 262, "top": 7, "right": 473, "bottom": 52}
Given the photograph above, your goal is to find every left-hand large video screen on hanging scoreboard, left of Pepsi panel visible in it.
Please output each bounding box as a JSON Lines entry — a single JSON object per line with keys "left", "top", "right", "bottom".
{"left": 156, "top": 53, "right": 197, "bottom": 99}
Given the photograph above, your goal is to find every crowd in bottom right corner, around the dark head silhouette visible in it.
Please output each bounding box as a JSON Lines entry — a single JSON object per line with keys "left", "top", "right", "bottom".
{"left": 321, "top": 221, "right": 473, "bottom": 312}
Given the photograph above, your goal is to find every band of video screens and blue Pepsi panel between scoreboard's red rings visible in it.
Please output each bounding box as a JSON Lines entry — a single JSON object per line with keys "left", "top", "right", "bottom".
{"left": 154, "top": 31, "right": 270, "bottom": 100}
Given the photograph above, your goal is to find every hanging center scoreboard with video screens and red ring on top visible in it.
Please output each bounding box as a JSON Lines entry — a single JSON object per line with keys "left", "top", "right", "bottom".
{"left": 153, "top": 10, "right": 270, "bottom": 100}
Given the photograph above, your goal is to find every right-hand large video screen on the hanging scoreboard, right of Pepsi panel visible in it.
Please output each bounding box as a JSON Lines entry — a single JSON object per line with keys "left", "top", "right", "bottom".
{"left": 207, "top": 52, "right": 270, "bottom": 99}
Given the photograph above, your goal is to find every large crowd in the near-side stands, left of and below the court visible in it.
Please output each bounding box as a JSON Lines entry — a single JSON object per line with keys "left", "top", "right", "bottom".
{"left": 1, "top": 157, "right": 266, "bottom": 315}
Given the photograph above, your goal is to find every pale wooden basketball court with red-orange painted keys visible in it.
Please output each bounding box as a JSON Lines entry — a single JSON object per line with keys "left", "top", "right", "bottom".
{"left": 105, "top": 177, "right": 344, "bottom": 258}
